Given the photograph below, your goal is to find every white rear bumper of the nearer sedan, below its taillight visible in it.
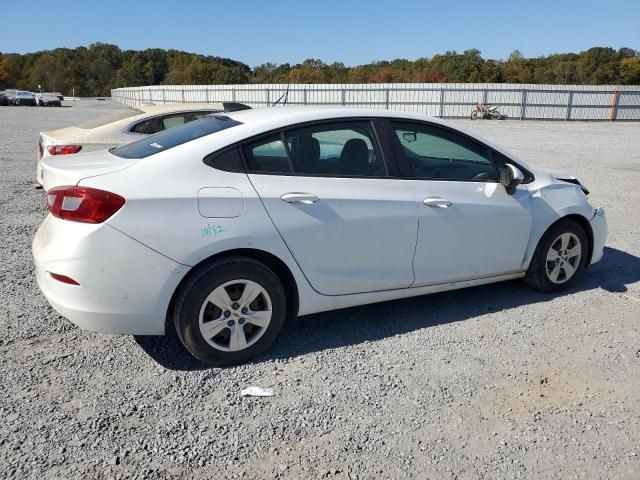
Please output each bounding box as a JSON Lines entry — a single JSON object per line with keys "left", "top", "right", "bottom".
{"left": 33, "top": 215, "right": 189, "bottom": 335}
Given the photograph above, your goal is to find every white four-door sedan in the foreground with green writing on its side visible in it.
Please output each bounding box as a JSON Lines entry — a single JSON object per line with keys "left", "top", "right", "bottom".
{"left": 33, "top": 107, "right": 607, "bottom": 365}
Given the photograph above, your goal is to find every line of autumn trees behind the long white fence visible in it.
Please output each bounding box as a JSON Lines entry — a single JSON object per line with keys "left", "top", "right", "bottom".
{"left": 0, "top": 43, "right": 640, "bottom": 96}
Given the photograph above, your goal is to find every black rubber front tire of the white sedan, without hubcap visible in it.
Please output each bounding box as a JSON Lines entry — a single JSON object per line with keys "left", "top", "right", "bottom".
{"left": 524, "top": 220, "right": 590, "bottom": 292}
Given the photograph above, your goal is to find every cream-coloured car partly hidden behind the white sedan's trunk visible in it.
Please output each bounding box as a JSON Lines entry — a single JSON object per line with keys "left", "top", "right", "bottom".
{"left": 36, "top": 103, "right": 249, "bottom": 185}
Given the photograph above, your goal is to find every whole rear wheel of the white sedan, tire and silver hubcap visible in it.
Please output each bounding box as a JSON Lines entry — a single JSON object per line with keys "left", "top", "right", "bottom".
{"left": 173, "top": 257, "right": 287, "bottom": 365}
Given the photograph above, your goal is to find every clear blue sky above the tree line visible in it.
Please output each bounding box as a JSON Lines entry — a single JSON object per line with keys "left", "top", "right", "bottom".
{"left": 0, "top": 0, "right": 640, "bottom": 67}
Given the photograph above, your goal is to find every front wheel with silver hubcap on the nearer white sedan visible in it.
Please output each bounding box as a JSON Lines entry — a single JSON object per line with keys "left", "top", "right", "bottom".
{"left": 525, "top": 220, "right": 589, "bottom": 292}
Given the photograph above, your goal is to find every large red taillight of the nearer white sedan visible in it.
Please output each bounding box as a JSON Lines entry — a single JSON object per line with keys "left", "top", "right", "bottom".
{"left": 47, "top": 187, "right": 126, "bottom": 223}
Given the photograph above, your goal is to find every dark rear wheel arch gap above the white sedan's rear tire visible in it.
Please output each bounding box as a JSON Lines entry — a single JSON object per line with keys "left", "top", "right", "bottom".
{"left": 164, "top": 248, "right": 300, "bottom": 334}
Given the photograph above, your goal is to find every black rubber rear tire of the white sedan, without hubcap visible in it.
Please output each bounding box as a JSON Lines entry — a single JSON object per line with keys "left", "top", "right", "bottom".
{"left": 173, "top": 256, "right": 287, "bottom": 366}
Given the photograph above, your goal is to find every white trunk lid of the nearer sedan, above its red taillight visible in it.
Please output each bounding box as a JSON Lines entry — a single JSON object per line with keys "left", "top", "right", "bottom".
{"left": 41, "top": 150, "right": 137, "bottom": 190}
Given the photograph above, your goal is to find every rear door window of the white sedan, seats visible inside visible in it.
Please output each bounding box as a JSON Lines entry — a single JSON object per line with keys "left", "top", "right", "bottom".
{"left": 285, "top": 121, "right": 386, "bottom": 177}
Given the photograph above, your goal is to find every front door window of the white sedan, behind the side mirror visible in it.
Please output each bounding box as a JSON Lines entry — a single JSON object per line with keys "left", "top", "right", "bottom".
{"left": 392, "top": 122, "right": 498, "bottom": 182}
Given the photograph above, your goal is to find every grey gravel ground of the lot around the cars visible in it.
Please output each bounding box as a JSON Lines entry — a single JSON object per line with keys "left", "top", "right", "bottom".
{"left": 0, "top": 101, "right": 640, "bottom": 480}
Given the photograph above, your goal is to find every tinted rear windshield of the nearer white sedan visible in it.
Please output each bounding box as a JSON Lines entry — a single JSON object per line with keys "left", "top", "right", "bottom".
{"left": 111, "top": 115, "right": 241, "bottom": 158}
